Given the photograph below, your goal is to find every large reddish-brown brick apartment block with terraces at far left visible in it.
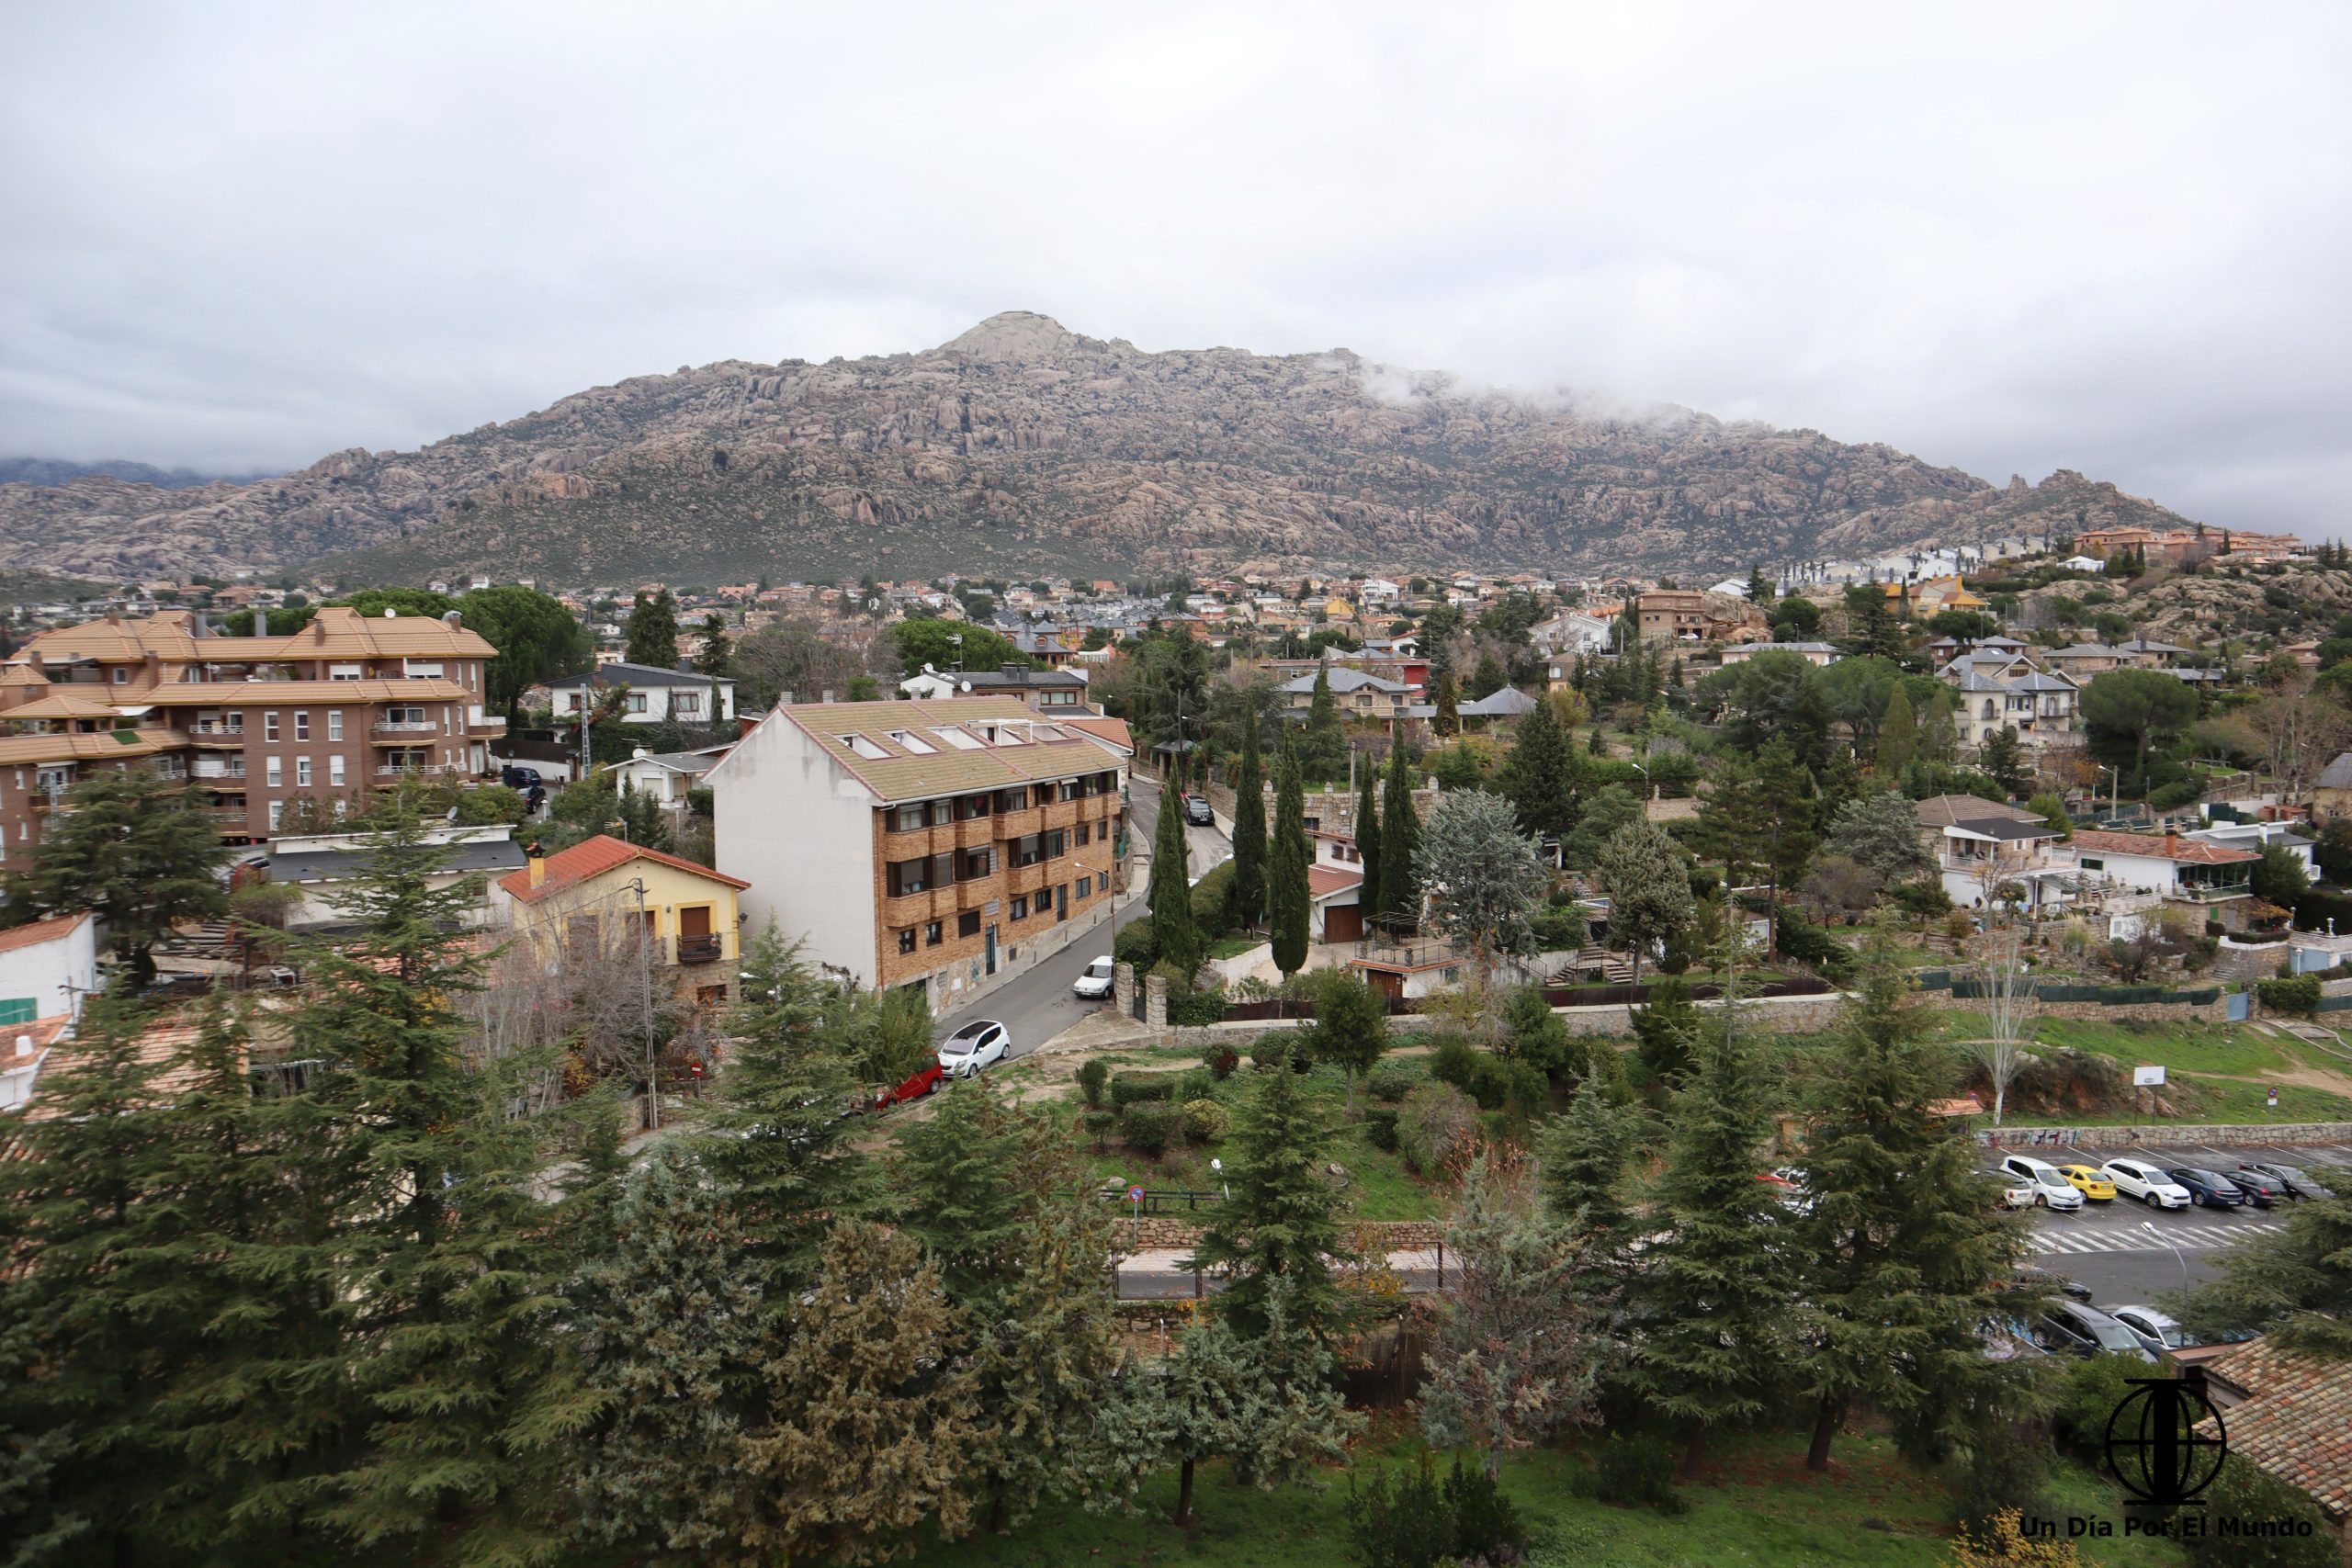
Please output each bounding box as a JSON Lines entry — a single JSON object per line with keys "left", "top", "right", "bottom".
{"left": 0, "top": 606, "right": 505, "bottom": 863}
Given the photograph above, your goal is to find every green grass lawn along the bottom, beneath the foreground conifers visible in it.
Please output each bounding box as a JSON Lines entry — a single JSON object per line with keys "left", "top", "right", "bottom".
{"left": 917, "top": 1425, "right": 2185, "bottom": 1568}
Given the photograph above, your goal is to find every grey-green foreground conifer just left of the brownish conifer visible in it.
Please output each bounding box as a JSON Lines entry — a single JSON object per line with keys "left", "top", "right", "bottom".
{"left": 571, "top": 1147, "right": 776, "bottom": 1561}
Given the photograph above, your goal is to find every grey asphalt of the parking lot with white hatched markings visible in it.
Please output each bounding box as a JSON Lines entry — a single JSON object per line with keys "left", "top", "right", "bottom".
{"left": 2013, "top": 1145, "right": 2352, "bottom": 1307}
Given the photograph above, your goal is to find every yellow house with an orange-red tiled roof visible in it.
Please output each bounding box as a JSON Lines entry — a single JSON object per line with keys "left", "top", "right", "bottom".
{"left": 492, "top": 832, "right": 751, "bottom": 1001}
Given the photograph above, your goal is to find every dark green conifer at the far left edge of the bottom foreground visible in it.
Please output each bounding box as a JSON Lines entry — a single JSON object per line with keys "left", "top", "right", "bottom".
{"left": 0, "top": 995, "right": 184, "bottom": 1563}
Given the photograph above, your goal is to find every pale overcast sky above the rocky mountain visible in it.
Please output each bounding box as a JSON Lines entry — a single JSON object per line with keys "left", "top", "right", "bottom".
{"left": 0, "top": 0, "right": 2352, "bottom": 536}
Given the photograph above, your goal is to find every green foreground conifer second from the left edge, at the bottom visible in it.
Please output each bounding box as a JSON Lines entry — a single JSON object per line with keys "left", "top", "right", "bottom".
{"left": 148, "top": 992, "right": 356, "bottom": 1561}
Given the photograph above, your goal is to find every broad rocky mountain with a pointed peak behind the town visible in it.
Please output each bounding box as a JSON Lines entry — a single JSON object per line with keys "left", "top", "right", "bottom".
{"left": 0, "top": 312, "right": 2178, "bottom": 583}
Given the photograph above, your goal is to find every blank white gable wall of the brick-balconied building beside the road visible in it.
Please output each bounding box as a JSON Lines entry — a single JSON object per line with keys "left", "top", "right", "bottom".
{"left": 703, "top": 715, "right": 879, "bottom": 985}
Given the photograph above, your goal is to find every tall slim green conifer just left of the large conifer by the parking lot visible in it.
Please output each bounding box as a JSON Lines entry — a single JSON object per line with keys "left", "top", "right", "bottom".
{"left": 1633, "top": 954, "right": 1792, "bottom": 1479}
